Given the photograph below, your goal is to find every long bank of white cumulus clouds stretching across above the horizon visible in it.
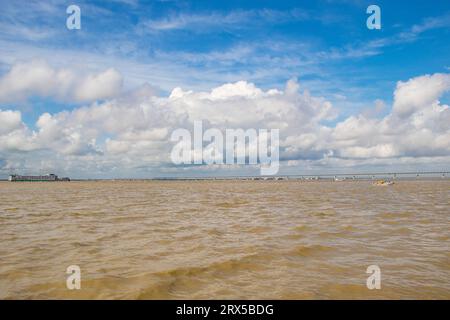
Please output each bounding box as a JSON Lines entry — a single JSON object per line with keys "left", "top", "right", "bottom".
{"left": 0, "top": 72, "right": 450, "bottom": 176}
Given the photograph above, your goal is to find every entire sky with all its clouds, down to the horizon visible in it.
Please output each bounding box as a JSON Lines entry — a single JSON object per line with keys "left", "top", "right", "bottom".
{"left": 0, "top": 0, "right": 450, "bottom": 178}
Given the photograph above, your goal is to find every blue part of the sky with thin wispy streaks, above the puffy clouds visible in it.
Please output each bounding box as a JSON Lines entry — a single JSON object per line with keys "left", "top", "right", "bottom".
{"left": 0, "top": 0, "right": 450, "bottom": 178}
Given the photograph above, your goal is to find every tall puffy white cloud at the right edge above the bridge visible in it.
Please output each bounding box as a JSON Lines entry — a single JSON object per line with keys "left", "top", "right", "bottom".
{"left": 332, "top": 74, "right": 450, "bottom": 158}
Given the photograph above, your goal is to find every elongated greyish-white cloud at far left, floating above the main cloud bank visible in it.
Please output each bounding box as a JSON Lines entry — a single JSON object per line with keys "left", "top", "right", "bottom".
{"left": 0, "top": 60, "right": 123, "bottom": 102}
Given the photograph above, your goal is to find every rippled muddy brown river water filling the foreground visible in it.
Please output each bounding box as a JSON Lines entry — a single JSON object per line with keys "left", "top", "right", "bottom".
{"left": 0, "top": 180, "right": 450, "bottom": 299}
